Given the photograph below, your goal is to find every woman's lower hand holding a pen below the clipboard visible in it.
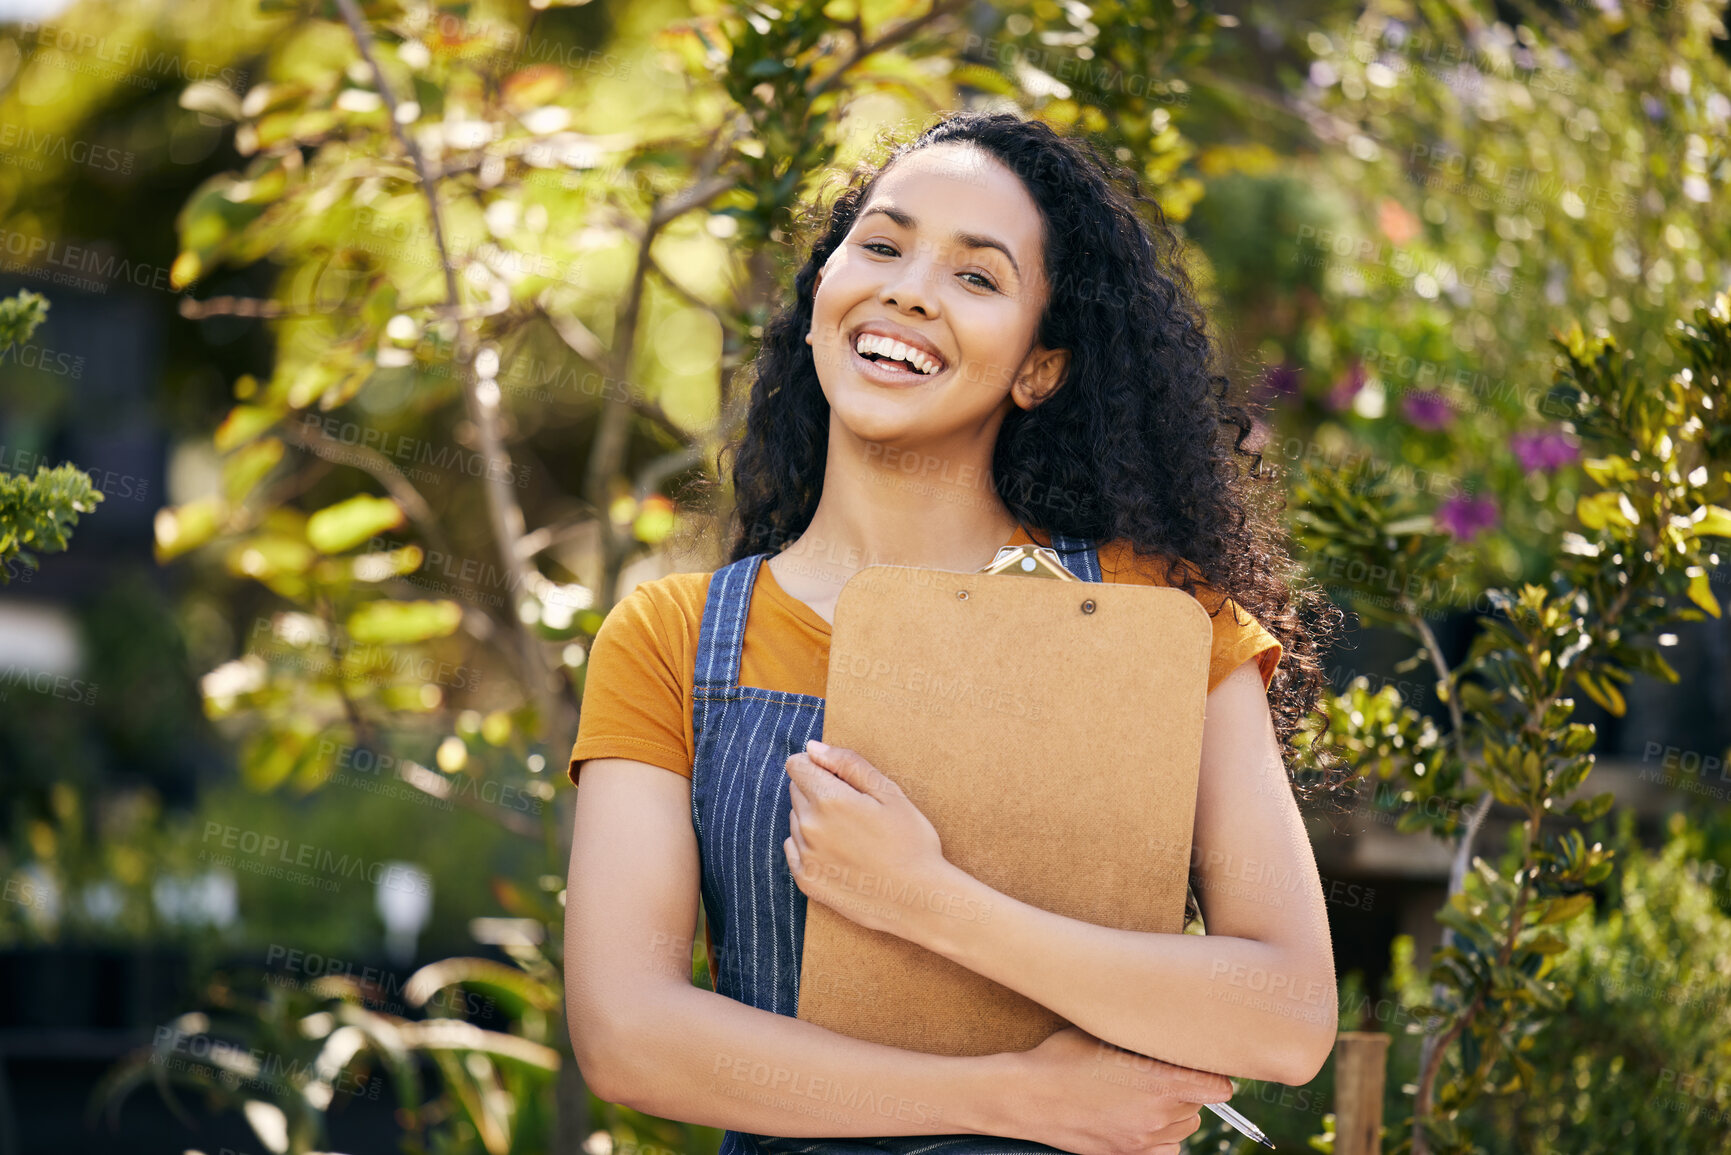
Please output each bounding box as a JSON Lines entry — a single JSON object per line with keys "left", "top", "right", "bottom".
{"left": 994, "top": 1027, "right": 1232, "bottom": 1155}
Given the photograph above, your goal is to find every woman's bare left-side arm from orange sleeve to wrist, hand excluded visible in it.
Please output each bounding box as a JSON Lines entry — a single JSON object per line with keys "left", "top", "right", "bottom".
{"left": 564, "top": 758, "right": 1020, "bottom": 1138}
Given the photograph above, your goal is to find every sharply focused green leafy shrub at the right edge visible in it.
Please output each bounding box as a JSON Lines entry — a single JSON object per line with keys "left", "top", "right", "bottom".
{"left": 1295, "top": 293, "right": 1731, "bottom": 1155}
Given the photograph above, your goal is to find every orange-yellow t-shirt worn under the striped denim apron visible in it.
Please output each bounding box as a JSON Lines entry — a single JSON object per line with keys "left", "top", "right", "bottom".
{"left": 568, "top": 530, "right": 1281, "bottom": 783}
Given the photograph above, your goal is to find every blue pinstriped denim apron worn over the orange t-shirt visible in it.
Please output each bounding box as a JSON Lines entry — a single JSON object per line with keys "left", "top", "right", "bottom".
{"left": 691, "top": 533, "right": 1101, "bottom": 1155}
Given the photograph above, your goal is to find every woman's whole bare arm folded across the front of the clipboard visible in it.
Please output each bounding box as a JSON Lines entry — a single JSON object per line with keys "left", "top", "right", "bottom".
{"left": 793, "top": 661, "right": 1336, "bottom": 1086}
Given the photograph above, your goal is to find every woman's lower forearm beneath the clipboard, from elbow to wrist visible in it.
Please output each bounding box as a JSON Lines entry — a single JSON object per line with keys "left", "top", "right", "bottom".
{"left": 608, "top": 984, "right": 1013, "bottom": 1138}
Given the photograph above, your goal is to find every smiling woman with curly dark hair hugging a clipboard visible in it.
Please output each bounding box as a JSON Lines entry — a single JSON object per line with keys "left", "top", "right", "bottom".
{"left": 566, "top": 113, "right": 1335, "bottom": 1155}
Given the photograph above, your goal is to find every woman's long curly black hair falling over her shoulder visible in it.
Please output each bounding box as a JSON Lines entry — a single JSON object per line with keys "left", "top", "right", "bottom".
{"left": 722, "top": 111, "right": 1342, "bottom": 813}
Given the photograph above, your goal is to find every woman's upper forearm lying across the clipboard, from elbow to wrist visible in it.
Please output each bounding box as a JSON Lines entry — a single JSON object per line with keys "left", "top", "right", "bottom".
{"left": 911, "top": 869, "right": 1336, "bottom": 1084}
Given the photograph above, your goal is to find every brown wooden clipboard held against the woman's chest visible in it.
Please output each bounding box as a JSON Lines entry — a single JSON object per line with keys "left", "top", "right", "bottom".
{"left": 798, "top": 566, "right": 1213, "bottom": 1055}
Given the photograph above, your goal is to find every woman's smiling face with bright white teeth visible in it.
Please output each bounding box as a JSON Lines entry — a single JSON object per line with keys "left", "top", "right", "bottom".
{"left": 807, "top": 144, "right": 1066, "bottom": 450}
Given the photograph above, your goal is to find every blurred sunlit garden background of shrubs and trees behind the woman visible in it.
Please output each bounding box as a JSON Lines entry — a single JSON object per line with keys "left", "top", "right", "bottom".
{"left": 0, "top": 0, "right": 1731, "bottom": 1155}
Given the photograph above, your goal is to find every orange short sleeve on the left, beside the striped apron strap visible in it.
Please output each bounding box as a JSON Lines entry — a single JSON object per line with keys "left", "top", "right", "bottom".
{"left": 566, "top": 584, "right": 691, "bottom": 783}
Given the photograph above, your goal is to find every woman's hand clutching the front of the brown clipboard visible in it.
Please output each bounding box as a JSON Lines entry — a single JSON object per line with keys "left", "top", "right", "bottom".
{"left": 782, "top": 741, "right": 956, "bottom": 939}
